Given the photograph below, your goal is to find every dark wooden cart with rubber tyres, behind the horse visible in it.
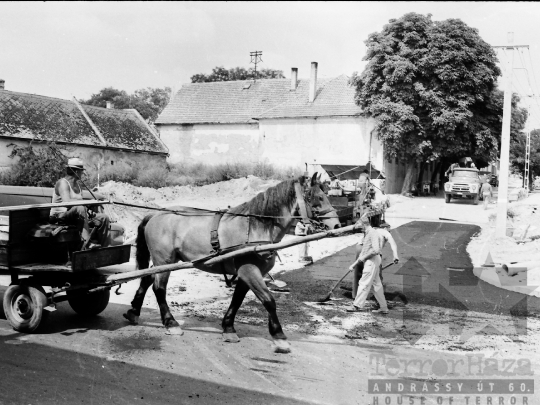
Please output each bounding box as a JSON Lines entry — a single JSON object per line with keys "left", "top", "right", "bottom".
{"left": 0, "top": 200, "right": 131, "bottom": 332}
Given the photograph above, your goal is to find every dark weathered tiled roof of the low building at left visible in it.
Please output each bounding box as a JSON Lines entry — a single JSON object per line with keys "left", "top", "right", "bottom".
{"left": 0, "top": 90, "right": 167, "bottom": 153}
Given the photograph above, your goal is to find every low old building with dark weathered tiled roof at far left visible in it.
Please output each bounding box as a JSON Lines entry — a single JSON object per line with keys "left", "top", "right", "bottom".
{"left": 0, "top": 81, "right": 168, "bottom": 174}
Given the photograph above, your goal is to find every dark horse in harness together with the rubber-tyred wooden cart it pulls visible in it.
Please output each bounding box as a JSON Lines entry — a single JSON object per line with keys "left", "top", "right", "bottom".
{"left": 0, "top": 173, "right": 381, "bottom": 342}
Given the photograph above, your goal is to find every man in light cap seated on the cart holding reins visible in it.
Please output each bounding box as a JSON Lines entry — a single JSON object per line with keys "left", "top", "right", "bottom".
{"left": 50, "top": 158, "right": 109, "bottom": 249}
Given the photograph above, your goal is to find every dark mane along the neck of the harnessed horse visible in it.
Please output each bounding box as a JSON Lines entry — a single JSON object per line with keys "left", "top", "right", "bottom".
{"left": 228, "top": 179, "right": 297, "bottom": 221}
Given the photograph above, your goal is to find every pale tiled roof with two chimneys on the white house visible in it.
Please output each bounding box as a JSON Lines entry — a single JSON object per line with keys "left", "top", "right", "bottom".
{"left": 156, "top": 76, "right": 361, "bottom": 124}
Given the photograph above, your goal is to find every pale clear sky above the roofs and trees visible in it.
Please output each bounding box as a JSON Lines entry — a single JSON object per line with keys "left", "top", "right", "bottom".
{"left": 0, "top": 1, "right": 540, "bottom": 128}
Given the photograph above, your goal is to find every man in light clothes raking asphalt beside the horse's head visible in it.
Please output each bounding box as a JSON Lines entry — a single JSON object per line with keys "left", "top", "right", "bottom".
{"left": 347, "top": 214, "right": 399, "bottom": 314}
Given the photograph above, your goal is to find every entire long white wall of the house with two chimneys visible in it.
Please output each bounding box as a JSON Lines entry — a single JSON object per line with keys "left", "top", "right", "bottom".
{"left": 153, "top": 117, "right": 405, "bottom": 192}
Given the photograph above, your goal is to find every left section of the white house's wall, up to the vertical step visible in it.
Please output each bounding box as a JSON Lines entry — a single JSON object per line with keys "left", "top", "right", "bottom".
{"left": 158, "top": 124, "right": 259, "bottom": 164}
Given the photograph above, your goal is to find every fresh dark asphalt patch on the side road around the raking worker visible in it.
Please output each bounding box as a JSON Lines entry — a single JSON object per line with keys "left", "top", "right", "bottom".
{"left": 310, "top": 221, "right": 540, "bottom": 316}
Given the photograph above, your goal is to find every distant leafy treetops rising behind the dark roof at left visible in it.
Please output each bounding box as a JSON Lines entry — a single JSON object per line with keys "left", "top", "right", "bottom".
{"left": 80, "top": 87, "right": 171, "bottom": 123}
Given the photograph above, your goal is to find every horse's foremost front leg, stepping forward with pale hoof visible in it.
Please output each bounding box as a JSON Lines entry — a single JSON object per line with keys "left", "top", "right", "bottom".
{"left": 238, "top": 264, "right": 291, "bottom": 353}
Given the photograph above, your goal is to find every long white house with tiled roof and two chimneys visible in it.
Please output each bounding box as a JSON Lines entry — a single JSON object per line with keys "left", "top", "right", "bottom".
{"left": 156, "top": 62, "right": 405, "bottom": 192}
